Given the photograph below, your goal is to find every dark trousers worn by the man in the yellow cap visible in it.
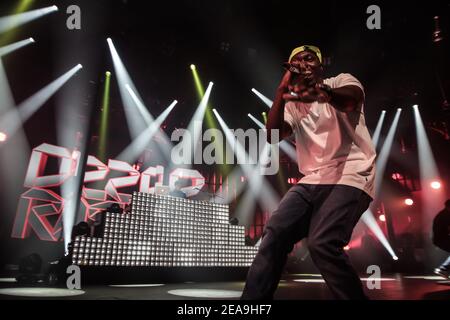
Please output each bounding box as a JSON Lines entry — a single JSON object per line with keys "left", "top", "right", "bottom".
{"left": 241, "top": 184, "right": 371, "bottom": 300}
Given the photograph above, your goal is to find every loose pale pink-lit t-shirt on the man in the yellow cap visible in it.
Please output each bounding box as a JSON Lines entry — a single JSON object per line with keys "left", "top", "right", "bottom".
{"left": 284, "top": 73, "right": 376, "bottom": 198}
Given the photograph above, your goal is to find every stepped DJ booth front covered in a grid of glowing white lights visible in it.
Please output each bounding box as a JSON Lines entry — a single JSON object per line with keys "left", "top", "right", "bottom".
{"left": 72, "top": 192, "right": 258, "bottom": 267}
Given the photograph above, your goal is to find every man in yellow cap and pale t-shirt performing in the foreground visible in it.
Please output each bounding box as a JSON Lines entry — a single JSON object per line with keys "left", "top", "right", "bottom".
{"left": 241, "top": 46, "right": 375, "bottom": 299}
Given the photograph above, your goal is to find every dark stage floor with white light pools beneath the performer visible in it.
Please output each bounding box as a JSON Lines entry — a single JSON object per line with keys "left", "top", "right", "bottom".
{"left": 0, "top": 274, "right": 450, "bottom": 300}
